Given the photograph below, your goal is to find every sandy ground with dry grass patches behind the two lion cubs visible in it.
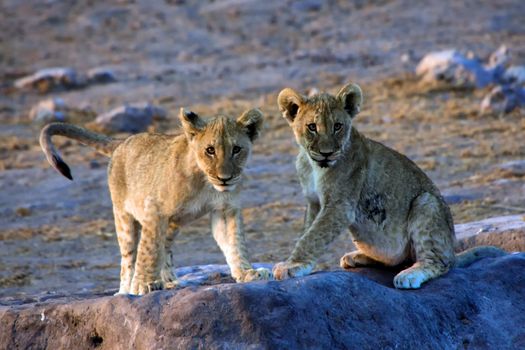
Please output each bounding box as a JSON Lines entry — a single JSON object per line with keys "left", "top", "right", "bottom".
{"left": 0, "top": 0, "right": 525, "bottom": 298}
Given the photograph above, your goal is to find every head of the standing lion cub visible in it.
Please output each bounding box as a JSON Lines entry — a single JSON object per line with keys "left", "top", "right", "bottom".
{"left": 179, "top": 108, "right": 263, "bottom": 192}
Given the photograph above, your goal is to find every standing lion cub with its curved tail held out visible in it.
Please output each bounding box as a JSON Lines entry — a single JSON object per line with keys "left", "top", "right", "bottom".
{"left": 40, "top": 109, "right": 271, "bottom": 295}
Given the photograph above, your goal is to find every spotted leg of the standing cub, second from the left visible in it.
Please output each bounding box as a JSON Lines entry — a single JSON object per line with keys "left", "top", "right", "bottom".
{"left": 130, "top": 198, "right": 168, "bottom": 295}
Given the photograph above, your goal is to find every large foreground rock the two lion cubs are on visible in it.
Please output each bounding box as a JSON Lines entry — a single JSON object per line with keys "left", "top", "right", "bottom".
{"left": 0, "top": 253, "right": 525, "bottom": 349}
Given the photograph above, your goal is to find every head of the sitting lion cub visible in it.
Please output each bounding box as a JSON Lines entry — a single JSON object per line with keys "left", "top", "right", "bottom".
{"left": 277, "top": 84, "right": 363, "bottom": 168}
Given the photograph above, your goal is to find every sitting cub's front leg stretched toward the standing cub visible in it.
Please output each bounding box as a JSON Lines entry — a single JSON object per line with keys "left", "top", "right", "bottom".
{"left": 273, "top": 206, "right": 349, "bottom": 280}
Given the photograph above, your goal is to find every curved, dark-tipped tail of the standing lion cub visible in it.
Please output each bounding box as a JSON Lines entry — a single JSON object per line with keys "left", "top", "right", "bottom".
{"left": 40, "top": 123, "right": 122, "bottom": 180}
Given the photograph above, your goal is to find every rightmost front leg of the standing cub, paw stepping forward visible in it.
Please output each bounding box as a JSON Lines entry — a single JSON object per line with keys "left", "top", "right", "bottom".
{"left": 211, "top": 206, "right": 271, "bottom": 282}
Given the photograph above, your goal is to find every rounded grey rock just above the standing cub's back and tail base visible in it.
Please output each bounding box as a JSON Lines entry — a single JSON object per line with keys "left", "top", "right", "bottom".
{"left": 95, "top": 103, "right": 167, "bottom": 133}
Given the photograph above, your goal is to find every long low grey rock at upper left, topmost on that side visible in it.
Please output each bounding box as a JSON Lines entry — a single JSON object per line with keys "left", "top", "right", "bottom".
{"left": 15, "top": 67, "right": 86, "bottom": 93}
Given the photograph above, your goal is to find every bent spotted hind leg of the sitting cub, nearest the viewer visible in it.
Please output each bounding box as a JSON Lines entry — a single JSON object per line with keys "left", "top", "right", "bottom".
{"left": 394, "top": 193, "right": 455, "bottom": 289}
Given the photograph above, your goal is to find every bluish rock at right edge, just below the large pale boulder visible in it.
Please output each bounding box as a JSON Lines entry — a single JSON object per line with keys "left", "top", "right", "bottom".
{"left": 480, "top": 84, "right": 525, "bottom": 114}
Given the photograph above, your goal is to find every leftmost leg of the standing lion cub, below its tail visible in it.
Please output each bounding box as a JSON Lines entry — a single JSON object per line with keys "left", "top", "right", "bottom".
{"left": 113, "top": 208, "right": 139, "bottom": 294}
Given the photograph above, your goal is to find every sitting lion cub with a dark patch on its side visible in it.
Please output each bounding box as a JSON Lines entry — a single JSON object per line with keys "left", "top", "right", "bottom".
{"left": 273, "top": 84, "right": 503, "bottom": 288}
